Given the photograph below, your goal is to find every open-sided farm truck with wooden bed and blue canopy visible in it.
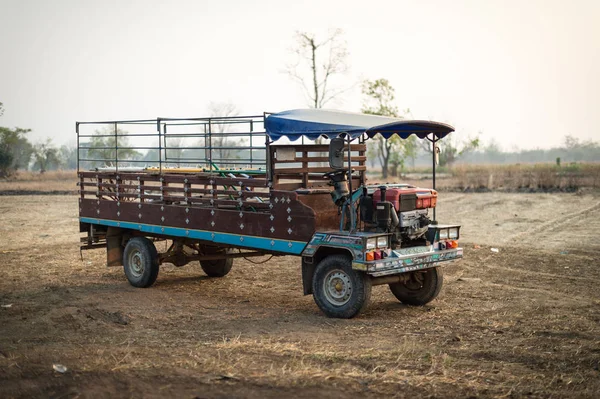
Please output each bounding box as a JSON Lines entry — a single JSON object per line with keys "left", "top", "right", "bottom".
{"left": 76, "top": 109, "right": 463, "bottom": 318}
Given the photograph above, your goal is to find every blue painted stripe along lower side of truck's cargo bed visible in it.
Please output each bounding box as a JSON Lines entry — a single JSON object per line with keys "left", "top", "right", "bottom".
{"left": 79, "top": 217, "right": 307, "bottom": 255}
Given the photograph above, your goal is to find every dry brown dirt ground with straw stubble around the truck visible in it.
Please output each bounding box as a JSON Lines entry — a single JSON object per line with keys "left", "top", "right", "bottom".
{"left": 0, "top": 193, "right": 600, "bottom": 398}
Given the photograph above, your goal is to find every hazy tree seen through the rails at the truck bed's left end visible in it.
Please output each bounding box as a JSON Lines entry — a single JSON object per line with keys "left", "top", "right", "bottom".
{"left": 84, "top": 127, "right": 142, "bottom": 166}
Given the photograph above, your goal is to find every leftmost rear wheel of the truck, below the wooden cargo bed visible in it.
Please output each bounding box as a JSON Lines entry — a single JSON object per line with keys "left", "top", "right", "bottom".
{"left": 123, "top": 237, "right": 159, "bottom": 288}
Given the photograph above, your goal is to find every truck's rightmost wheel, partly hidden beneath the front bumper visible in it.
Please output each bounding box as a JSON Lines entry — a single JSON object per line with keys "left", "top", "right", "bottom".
{"left": 390, "top": 267, "right": 444, "bottom": 306}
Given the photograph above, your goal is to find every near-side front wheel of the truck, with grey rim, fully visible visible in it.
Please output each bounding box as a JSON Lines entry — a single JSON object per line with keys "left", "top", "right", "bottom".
{"left": 312, "top": 255, "right": 371, "bottom": 319}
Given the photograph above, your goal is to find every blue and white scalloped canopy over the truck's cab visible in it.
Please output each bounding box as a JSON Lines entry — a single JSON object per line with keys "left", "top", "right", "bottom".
{"left": 265, "top": 109, "right": 454, "bottom": 141}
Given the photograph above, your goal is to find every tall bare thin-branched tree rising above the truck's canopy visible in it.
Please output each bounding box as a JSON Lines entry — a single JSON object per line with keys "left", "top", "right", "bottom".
{"left": 286, "top": 29, "right": 348, "bottom": 108}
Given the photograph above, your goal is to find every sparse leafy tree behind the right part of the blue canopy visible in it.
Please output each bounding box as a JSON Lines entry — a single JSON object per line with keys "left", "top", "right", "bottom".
{"left": 361, "top": 79, "right": 410, "bottom": 179}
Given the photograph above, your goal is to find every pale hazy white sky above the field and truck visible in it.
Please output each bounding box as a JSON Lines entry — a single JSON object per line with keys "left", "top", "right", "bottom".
{"left": 0, "top": 0, "right": 600, "bottom": 150}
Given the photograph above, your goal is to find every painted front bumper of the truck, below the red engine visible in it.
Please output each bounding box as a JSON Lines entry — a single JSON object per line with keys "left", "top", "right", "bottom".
{"left": 352, "top": 247, "right": 463, "bottom": 277}
